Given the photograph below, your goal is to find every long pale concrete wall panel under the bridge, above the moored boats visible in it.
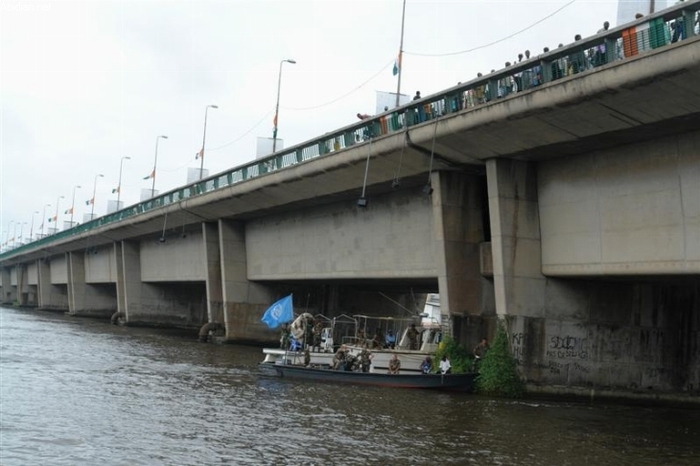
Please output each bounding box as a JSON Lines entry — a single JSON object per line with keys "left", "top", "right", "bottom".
{"left": 245, "top": 190, "right": 436, "bottom": 280}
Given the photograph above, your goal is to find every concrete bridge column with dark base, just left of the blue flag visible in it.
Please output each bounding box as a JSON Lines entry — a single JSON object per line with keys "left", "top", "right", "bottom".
{"left": 219, "top": 220, "right": 275, "bottom": 341}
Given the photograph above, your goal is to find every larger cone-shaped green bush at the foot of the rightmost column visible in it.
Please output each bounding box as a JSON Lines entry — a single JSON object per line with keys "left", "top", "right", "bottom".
{"left": 476, "top": 324, "right": 525, "bottom": 398}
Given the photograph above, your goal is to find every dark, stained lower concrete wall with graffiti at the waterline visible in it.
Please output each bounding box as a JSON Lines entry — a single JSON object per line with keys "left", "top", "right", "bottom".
{"left": 507, "top": 279, "right": 700, "bottom": 393}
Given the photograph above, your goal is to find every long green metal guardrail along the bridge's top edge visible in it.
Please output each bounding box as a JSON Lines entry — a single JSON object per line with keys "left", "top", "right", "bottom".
{"left": 0, "top": 0, "right": 700, "bottom": 260}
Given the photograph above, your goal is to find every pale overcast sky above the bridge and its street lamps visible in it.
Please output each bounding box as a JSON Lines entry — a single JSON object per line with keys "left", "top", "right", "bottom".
{"left": 0, "top": 0, "right": 636, "bottom": 243}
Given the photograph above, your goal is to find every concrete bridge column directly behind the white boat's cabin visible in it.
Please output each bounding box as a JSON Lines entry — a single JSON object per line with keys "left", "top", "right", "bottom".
{"left": 431, "top": 172, "right": 490, "bottom": 337}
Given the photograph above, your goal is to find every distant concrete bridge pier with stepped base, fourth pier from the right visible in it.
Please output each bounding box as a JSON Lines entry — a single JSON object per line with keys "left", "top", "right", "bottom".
{"left": 67, "top": 251, "right": 115, "bottom": 317}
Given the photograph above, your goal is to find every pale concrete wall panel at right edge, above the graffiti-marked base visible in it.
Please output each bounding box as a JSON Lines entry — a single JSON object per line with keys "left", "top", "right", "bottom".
{"left": 538, "top": 131, "right": 700, "bottom": 276}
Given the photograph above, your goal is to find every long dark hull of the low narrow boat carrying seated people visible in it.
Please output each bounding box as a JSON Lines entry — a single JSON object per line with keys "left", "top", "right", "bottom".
{"left": 260, "top": 363, "right": 477, "bottom": 392}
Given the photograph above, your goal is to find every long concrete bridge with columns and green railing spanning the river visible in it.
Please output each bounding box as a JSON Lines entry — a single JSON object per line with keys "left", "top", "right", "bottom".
{"left": 0, "top": 1, "right": 700, "bottom": 400}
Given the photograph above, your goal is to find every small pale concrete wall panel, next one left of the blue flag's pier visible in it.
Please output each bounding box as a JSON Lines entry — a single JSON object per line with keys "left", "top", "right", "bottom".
{"left": 140, "top": 231, "right": 207, "bottom": 283}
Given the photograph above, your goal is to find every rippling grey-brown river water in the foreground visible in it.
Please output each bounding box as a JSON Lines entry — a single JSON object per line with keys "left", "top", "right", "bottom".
{"left": 0, "top": 308, "right": 700, "bottom": 466}
